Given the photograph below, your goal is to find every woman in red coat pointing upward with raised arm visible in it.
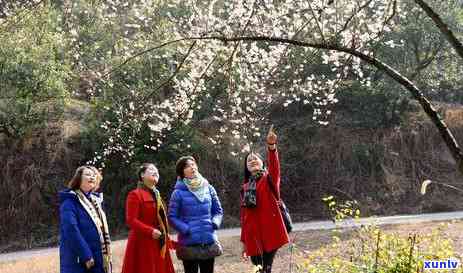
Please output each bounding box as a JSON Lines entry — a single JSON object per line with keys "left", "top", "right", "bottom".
{"left": 240, "top": 126, "right": 289, "bottom": 273}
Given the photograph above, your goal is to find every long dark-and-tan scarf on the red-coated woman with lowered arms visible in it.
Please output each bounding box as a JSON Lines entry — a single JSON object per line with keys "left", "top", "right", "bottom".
{"left": 137, "top": 182, "right": 169, "bottom": 258}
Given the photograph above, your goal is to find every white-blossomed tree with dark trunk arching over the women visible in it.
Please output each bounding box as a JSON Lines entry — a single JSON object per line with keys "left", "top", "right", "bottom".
{"left": 2, "top": 0, "right": 463, "bottom": 172}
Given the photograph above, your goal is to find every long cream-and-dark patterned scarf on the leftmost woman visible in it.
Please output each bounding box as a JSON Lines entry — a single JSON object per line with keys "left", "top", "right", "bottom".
{"left": 75, "top": 190, "right": 112, "bottom": 273}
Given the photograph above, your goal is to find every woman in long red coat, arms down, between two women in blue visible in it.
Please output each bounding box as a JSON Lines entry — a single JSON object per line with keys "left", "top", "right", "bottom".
{"left": 122, "top": 163, "right": 174, "bottom": 273}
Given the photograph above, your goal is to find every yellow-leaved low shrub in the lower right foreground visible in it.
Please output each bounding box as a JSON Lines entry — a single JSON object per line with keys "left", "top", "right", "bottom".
{"left": 298, "top": 196, "right": 463, "bottom": 273}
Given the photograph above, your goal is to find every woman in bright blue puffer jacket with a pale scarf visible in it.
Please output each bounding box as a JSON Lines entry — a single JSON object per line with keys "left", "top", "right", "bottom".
{"left": 169, "top": 156, "right": 223, "bottom": 273}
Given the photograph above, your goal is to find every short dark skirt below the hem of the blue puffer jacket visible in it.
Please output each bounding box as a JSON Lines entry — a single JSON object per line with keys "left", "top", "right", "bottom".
{"left": 175, "top": 241, "right": 223, "bottom": 260}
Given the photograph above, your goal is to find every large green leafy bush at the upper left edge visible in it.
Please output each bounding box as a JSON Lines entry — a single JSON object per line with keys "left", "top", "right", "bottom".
{"left": 0, "top": 5, "right": 72, "bottom": 139}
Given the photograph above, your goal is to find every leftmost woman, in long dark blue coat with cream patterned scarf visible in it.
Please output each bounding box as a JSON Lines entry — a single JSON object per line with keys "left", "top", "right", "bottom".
{"left": 59, "top": 166, "right": 112, "bottom": 273}
